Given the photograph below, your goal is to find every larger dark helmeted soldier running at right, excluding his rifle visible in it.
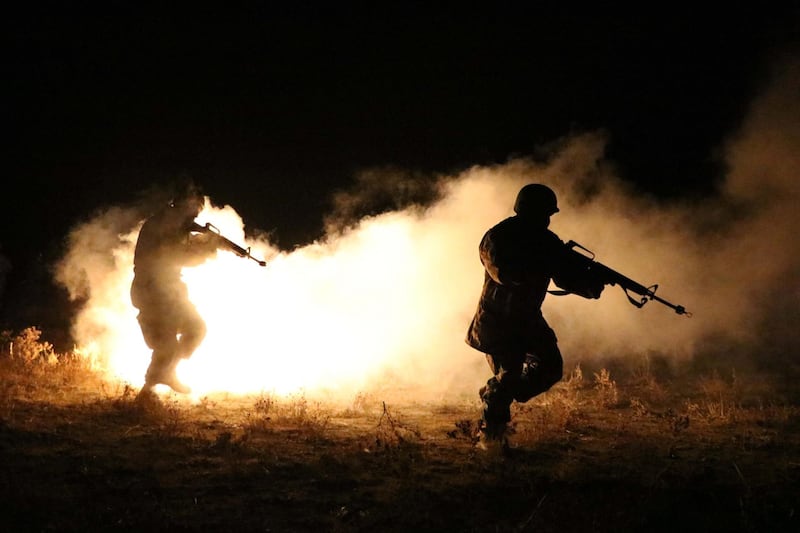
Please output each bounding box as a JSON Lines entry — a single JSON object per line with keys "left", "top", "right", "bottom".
{"left": 466, "top": 183, "right": 604, "bottom": 449}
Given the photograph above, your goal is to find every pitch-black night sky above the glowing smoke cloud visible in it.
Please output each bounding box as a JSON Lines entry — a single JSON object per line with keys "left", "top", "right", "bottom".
{"left": 0, "top": 1, "right": 798, "bottom": 340}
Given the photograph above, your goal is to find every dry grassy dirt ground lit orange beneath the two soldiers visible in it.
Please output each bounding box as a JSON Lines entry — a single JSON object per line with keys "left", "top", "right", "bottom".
{"left": 0, "top": 348, "right": 800, "bottom": 532}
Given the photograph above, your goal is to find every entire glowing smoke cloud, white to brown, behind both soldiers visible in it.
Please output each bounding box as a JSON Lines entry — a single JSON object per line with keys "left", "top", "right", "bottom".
{"left": 58, "top": 58, "right": 800, "bottom": 397}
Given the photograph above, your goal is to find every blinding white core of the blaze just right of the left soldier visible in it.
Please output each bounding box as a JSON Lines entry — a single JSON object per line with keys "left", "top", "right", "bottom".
{"left": 180, "top": 208, "right": 424, "bottom": 393}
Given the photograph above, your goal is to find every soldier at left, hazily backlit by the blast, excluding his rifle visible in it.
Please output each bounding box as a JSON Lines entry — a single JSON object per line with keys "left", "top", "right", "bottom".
{"left": 131, "top": 190, "right": 219, "bottom": 394}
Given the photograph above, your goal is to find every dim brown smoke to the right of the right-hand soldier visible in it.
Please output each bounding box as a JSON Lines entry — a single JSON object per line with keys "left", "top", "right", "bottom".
{"left": 547, "top": 55, "right": 800, "bottom": 370}
